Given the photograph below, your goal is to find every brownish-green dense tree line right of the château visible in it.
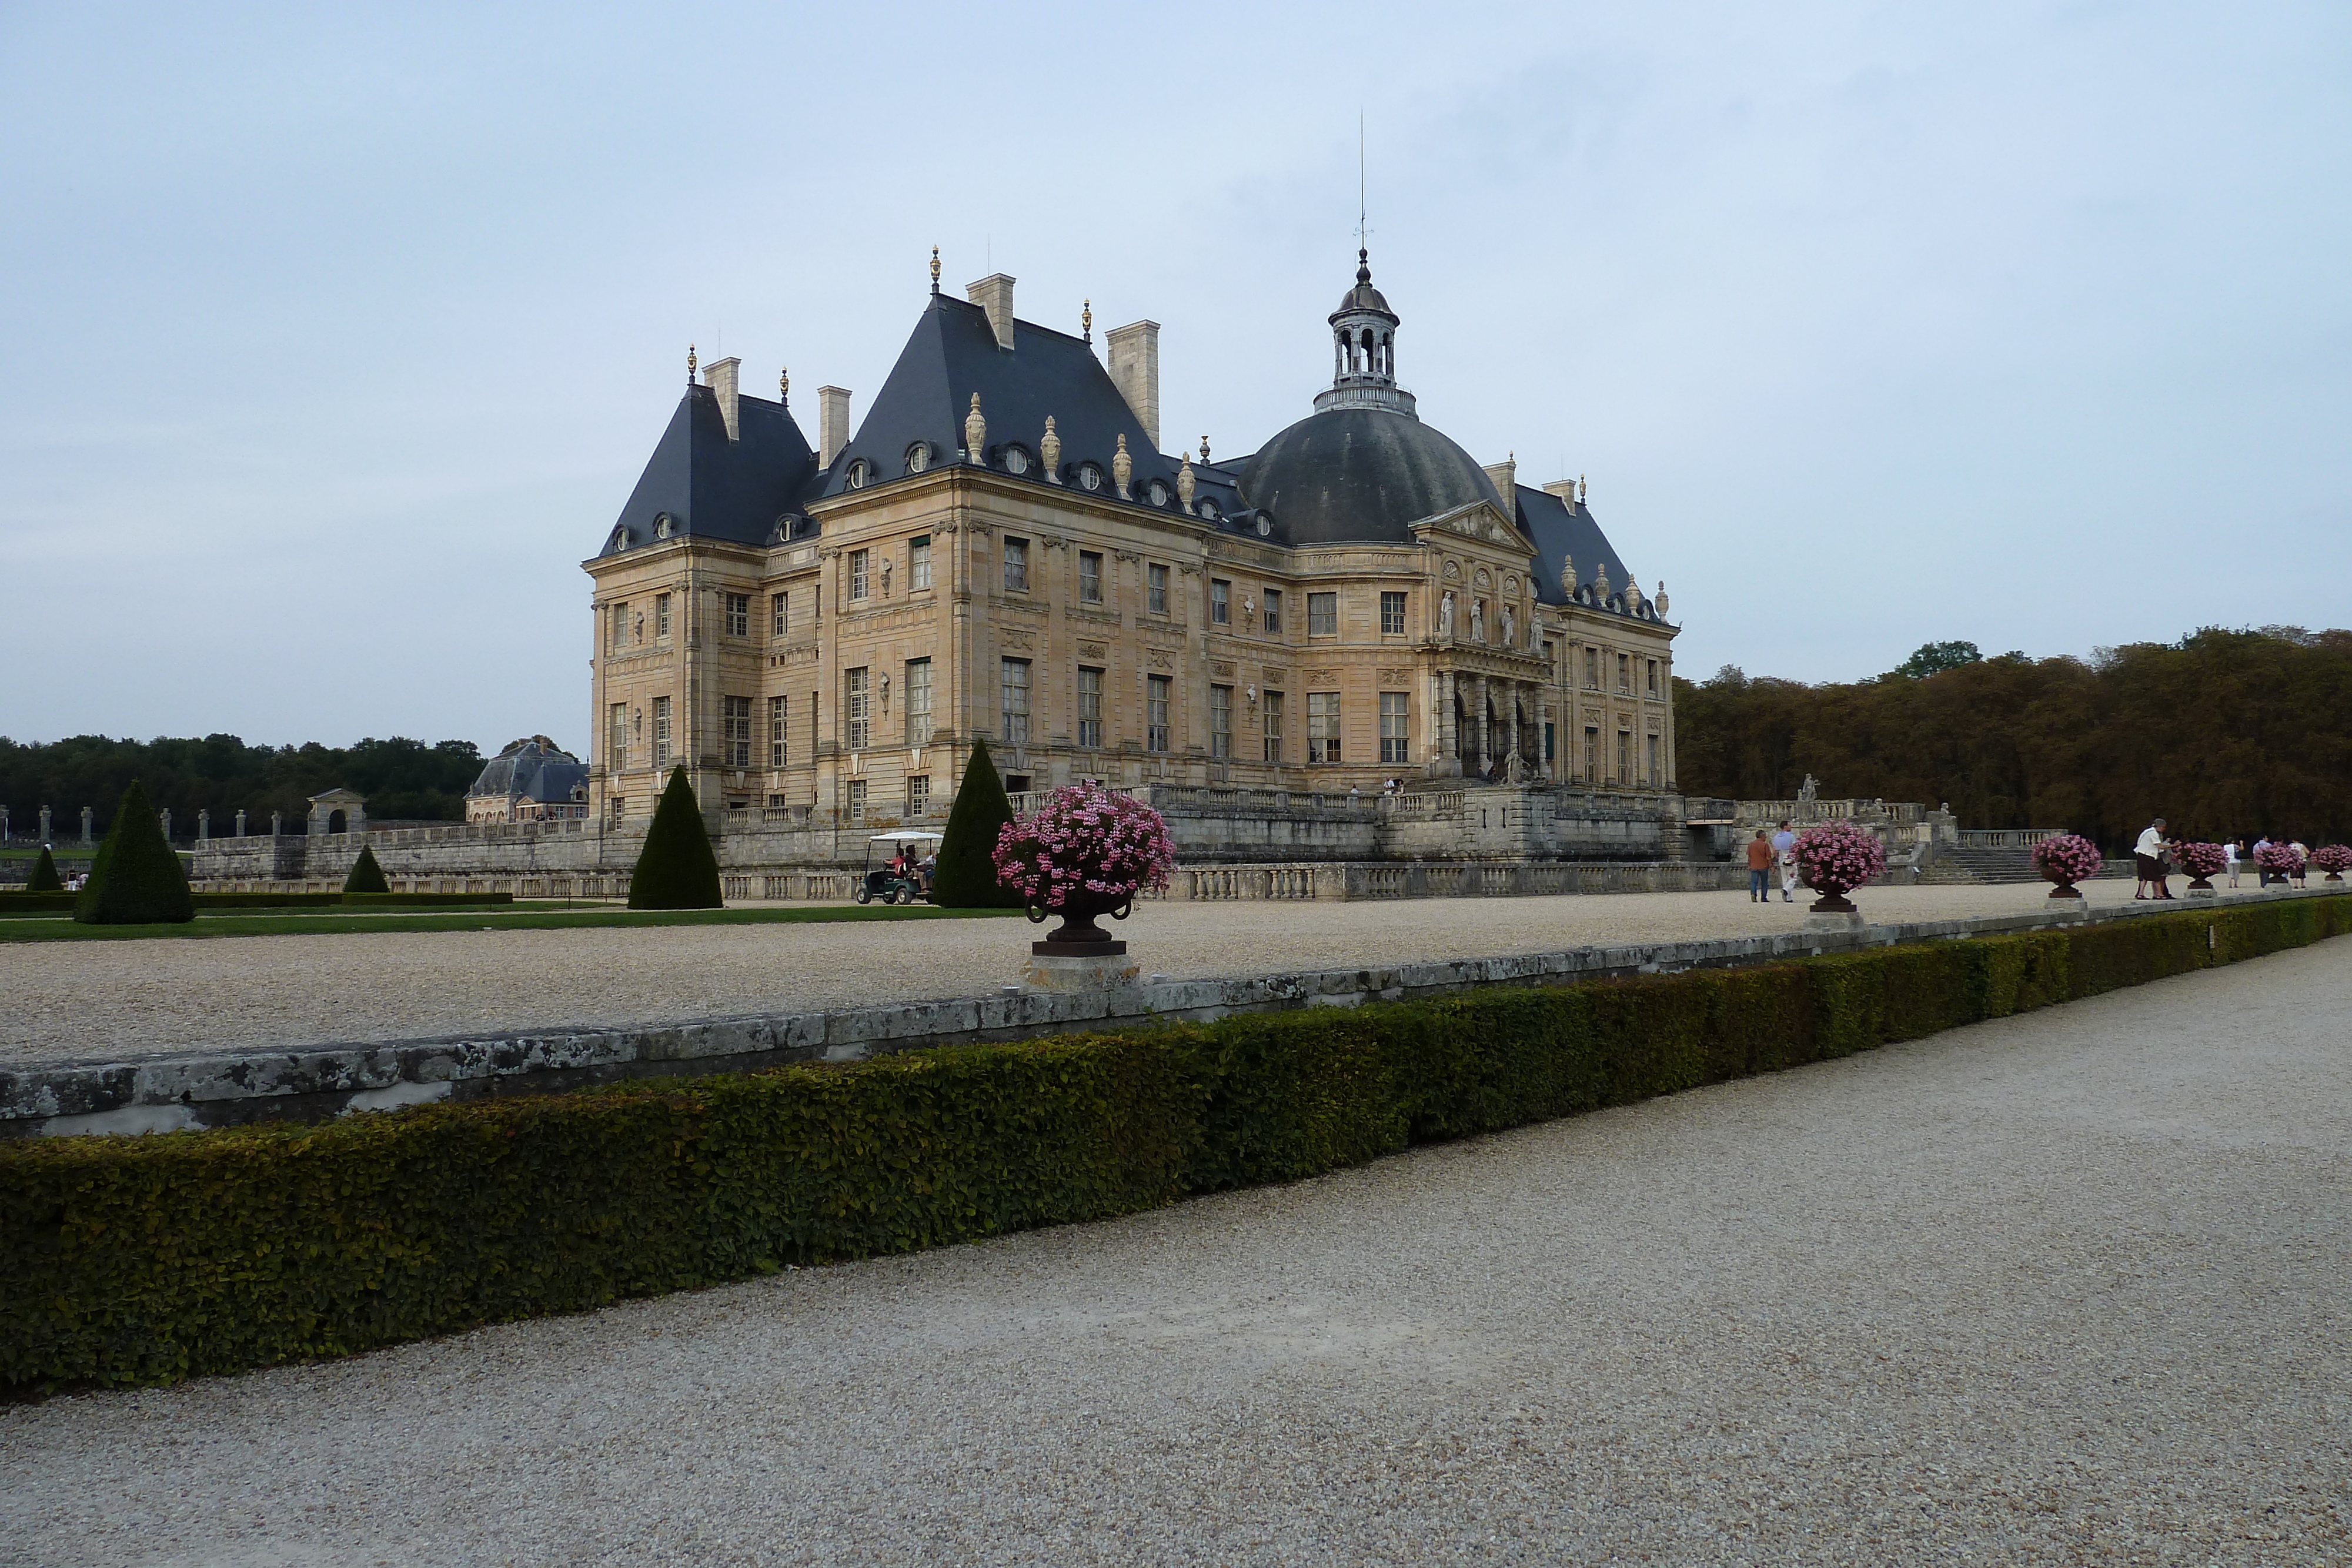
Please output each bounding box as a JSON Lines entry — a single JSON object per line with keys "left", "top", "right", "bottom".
{"left": 1675, "top": 626, "right": 2352, "bottom": 853}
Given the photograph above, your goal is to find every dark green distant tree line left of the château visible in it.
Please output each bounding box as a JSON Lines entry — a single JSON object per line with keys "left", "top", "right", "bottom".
{"left": 0, "top": 736, "right": 482, "bottom": 839}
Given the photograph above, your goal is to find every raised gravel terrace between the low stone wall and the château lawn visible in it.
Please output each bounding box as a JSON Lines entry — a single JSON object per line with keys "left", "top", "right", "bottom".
{"left": 0, "top": 881, "right": 2277, "bottom": 1065}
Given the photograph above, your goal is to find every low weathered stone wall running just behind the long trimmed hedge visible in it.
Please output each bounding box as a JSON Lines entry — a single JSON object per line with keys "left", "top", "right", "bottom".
{"left": 0, "top": 888, "right": 2340, "bottom": 1138}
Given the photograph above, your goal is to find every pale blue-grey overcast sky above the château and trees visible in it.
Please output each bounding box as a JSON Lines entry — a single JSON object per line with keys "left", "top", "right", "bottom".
{"left": 0, "top": 0, "right": 2352, "bottom": 750}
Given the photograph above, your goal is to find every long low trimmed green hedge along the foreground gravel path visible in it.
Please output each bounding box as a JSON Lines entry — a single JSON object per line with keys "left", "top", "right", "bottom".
{"left": 0, "top": 898, "right": 2352, "bottom": 1385}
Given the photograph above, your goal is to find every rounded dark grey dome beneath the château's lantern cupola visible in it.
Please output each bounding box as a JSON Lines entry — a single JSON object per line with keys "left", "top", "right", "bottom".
{"left": 1242, "top": 409, "right": 1512, "bottom": 546}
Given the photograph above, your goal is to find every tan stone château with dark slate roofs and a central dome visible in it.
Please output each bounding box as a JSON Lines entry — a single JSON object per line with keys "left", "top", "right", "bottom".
{"left": 586, "top": 252, "right": 1675, "bottom": 823}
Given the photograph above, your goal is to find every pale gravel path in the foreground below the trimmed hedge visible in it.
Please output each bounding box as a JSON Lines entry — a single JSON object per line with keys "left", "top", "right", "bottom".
{"left": 0, "top": 942, "right": 2352, "bottom": 1568}
